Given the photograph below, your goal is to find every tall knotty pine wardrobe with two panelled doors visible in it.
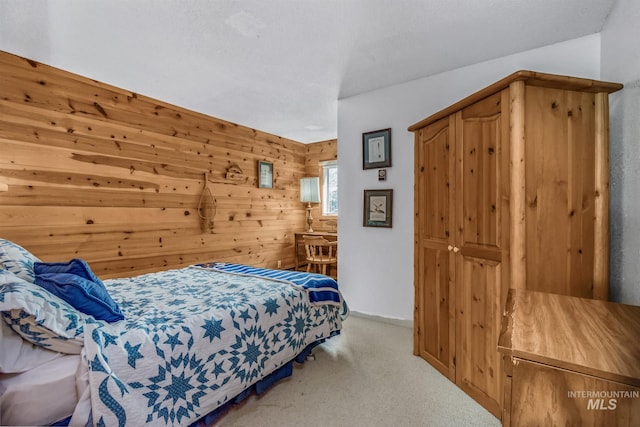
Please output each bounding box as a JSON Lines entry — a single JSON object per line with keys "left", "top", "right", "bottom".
{"left": 409, "top": 71, "right": 622, "bottom": 418}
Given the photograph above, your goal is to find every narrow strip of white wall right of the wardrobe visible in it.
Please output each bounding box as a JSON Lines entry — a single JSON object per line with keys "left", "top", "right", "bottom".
{"left": 601, "top": 0, "right": 640, "bottom": 305}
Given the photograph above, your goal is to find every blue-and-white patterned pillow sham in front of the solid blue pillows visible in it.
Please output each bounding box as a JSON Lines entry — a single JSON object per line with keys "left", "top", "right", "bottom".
{"left": 0, "top": 270, "right": 92, "bottom": 354}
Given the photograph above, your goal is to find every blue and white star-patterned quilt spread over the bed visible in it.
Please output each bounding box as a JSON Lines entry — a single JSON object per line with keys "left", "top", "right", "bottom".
{"left": 84, "top": 266, "right": 346, "bottom": 426}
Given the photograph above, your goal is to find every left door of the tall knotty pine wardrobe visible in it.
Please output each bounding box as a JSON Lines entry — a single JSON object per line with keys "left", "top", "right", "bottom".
{"left": 414, "top": 117, "right": 455, "bottom": 381}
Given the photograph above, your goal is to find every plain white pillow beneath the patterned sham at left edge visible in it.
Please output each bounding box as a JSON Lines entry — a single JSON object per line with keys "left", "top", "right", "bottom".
{"left": 0, "top": 319, "right": 62, "bottom": 374}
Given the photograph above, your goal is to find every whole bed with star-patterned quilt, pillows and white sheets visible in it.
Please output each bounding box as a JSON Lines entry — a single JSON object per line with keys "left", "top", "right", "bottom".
{"left": 0, "top": 239, "right": 348, "bottom": 426}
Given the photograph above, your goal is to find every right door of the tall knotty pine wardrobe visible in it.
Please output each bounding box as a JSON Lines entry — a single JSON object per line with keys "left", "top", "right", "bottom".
{"left": 454, "top": 91, "right": 509, "bottom": 418}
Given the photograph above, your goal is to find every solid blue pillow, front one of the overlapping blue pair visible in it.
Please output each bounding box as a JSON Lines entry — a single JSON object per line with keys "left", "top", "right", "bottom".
{"left": 36, "top": 273, "right": 124, "bottom": 322}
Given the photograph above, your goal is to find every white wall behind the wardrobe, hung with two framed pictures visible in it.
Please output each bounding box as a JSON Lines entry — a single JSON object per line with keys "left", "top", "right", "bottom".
{"left": 338, "top": 35, "right": 600, "bottom": 320}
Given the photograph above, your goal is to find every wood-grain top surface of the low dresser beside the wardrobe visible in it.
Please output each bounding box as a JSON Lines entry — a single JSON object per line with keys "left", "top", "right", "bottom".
{"left": 498, "top": 289, "right": 640, "bottom": 386}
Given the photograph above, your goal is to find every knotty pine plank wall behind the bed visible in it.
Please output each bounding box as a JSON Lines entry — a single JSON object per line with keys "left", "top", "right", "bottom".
{"left": 0, "top": 52, "right": 337, "bottom": 278}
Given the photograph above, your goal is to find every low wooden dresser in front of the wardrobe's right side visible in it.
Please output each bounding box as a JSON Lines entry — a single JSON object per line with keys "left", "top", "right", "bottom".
{"left": 498, "top": 289, "right": 640, "bottom": 426}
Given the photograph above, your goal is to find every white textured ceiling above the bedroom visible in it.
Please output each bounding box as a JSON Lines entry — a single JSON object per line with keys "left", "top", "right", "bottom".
{"left": 0, "top": 0, "right": 615, "bottom": 143}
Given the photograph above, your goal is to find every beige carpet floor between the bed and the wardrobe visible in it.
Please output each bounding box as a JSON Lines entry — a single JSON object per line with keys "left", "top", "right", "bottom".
{"left": 213, "top": 315, "right": 500, "bottom": 427}
